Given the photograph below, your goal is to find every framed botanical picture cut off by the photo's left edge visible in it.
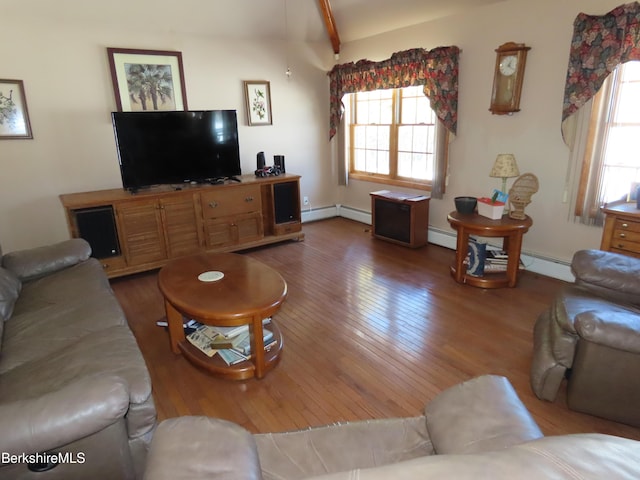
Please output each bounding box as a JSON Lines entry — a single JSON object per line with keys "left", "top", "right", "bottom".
{"left": 0, "top": 80, "right": 33, "bottom": 139}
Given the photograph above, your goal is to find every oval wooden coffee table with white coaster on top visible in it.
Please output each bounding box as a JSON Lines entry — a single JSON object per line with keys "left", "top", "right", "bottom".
{"left": 158, "top": 253, "right": 287, "bottom": 380}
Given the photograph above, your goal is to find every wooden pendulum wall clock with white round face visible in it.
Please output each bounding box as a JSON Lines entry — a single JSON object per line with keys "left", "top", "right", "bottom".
{"left": 489, "top": 42, "right": 531, "bottom": 115}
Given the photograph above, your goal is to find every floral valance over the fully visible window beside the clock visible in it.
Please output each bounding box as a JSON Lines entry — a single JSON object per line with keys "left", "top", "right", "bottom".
{"left": 328, "top": 47, "right": 460, "bottom": 139}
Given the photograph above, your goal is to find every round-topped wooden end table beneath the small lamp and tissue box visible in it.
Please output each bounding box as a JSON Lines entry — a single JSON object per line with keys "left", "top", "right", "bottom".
{"left": 447, "top": 212, "right": 533, "bottom": 288}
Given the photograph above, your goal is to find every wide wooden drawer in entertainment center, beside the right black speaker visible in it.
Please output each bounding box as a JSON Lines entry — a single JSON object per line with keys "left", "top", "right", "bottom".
{"left": 201, "top": 185, "right": 262, "bottom": 219}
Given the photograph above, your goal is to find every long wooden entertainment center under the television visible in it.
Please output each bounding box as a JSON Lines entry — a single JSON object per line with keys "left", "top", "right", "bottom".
{"left": 60, "top": 174, "right": 304, "bottom": 278}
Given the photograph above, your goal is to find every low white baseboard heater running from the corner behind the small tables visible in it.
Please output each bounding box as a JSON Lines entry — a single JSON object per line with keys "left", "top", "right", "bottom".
{"left": 302, "top": 204, "right": 575, "bottom": 283}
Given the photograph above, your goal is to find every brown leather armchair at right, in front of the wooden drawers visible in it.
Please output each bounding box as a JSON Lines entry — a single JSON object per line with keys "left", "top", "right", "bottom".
{"left": 531, "top": 250, "right": 640, "bottom": 426}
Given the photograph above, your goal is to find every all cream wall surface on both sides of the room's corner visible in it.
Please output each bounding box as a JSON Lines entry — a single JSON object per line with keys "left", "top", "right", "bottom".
{"left": 0, "top": 0, "right": 621, "bottom": 268}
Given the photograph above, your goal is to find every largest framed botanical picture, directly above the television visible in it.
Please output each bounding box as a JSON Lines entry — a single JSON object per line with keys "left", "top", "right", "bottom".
{"left": 107, "top": 48, "right": 188, "bottom": 112}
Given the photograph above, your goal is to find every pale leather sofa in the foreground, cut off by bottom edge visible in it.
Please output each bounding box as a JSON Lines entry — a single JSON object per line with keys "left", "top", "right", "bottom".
{"left": 144, "top": 375, "right": 640, "bottom": 480}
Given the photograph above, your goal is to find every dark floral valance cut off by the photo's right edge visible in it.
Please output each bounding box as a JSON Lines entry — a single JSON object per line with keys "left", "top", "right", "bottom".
{"left": 562, "top": 2, "right": 640, "bottom": 122}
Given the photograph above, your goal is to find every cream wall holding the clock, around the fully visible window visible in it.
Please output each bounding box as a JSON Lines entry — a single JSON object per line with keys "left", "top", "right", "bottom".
{"left": 339, "top": 0, "right": 623, "bottom": 262}
